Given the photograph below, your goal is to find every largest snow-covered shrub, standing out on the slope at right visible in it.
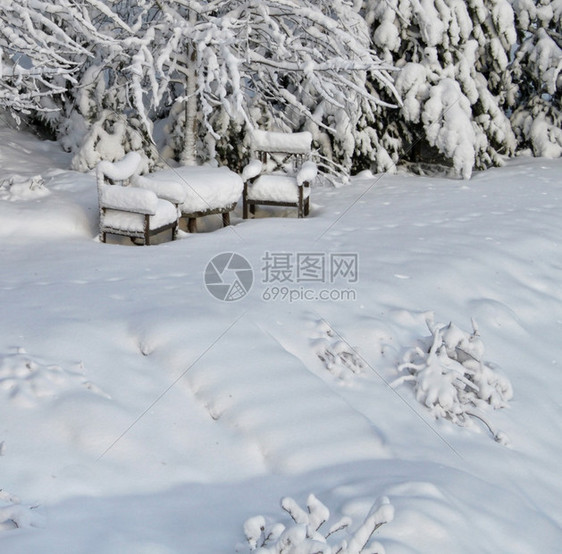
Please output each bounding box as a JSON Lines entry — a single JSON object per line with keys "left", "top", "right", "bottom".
{"left": 392, "top": 321, "right": 513, "bottom": 443}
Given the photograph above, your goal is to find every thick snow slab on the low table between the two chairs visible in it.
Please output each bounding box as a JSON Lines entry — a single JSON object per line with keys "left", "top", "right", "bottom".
{"left": 146, "top": 166, "right": 244, "bottom": 214}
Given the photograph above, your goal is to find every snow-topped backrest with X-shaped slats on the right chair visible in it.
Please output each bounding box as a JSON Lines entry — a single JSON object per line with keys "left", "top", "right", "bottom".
{"left": 252, "top": 131, "right": 312, "bottom": 172}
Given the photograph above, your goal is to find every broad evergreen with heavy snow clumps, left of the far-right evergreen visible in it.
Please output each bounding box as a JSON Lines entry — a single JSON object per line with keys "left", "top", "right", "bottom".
{"left": 358, "top": 0, "right": 516, "bottom": 178}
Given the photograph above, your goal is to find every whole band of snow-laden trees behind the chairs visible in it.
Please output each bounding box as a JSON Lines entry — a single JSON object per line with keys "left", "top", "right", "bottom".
{"left": 0, "top": 0, "right": 562, "bottom": 178}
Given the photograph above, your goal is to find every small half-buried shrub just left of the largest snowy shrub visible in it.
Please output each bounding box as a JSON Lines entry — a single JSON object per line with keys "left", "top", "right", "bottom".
{"left": 313, "top": 325, "right": 365, "bottom": 380}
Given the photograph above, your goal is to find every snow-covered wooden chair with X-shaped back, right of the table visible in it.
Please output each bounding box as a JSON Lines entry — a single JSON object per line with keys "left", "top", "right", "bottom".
{"left": 242, "top": 131, "right": 318, "bottom": 219}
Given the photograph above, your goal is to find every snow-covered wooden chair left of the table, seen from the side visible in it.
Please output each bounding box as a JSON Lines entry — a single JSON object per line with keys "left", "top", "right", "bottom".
{"left": 96, "top": 152, "right": 185, "bottom": 245}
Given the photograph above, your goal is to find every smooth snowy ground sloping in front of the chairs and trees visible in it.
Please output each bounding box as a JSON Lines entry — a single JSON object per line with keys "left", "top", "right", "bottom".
{"left": 0, "top": 123, "right": 562, "bottom": 554}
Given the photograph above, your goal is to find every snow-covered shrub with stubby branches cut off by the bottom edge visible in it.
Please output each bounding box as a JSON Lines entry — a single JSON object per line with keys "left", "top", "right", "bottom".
{"left": 237, "top": 494, "right": 394, "bottom": 554}
